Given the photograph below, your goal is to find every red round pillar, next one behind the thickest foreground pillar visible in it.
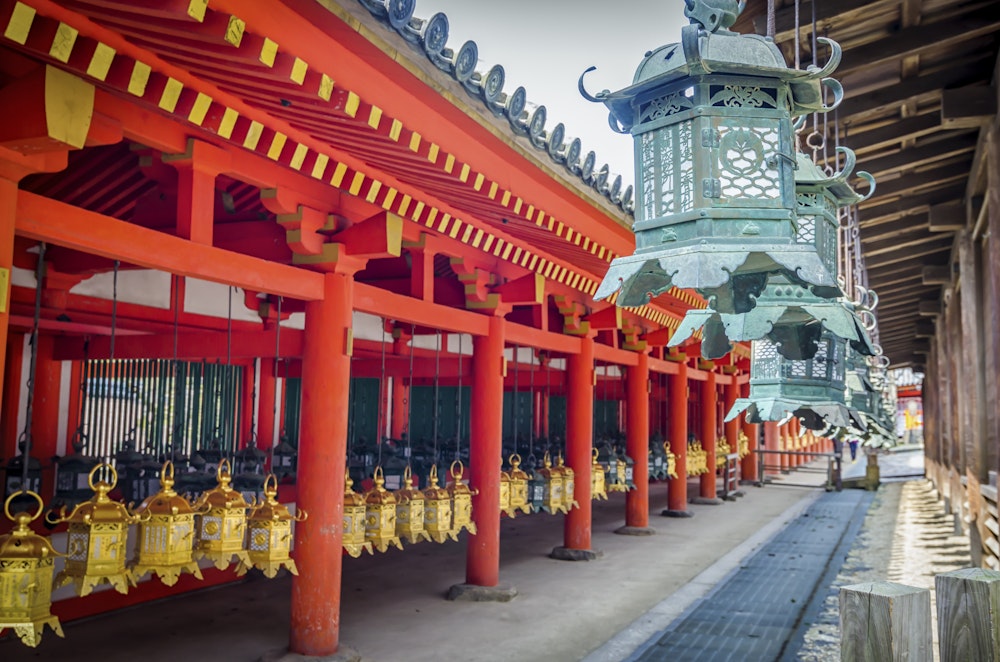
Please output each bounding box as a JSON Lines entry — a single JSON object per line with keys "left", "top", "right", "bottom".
{"left": 465, "top": 317, "right": 505, "bottom": 587}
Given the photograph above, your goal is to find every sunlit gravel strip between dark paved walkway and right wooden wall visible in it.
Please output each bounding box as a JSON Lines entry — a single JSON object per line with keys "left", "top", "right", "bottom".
{"left": 797, "top": 480, "right": 971, "bottom": 662}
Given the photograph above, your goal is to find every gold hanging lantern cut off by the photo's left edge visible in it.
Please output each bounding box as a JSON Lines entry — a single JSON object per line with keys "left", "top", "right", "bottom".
{"left": 0, "top": 492, "right": 63, "bottom": 648}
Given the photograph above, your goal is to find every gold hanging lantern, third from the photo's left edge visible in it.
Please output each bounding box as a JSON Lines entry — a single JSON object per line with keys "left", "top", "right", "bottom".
{"left": 129, "top": 460, "right": 202, "bottom": 586}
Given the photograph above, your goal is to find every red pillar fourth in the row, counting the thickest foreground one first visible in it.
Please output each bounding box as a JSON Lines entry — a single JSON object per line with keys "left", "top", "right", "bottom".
{"left": 616, "top": 352, "right": 653, "bottom": 535}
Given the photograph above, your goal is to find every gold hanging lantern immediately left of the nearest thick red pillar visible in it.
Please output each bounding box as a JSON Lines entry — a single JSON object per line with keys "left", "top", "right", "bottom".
{"left": 236, "top": 474, "right": 309, "bottom": 579}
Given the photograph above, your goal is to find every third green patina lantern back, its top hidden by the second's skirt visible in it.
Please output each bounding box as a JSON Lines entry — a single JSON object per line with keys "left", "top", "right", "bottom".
{"left": 726, "top": 332, "right": 863, "bottom": 430}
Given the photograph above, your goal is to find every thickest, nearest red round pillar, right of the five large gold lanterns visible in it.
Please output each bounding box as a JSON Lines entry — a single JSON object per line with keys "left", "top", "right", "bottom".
{"left": 289, "top": 273, "right": 354, "bottom": 656}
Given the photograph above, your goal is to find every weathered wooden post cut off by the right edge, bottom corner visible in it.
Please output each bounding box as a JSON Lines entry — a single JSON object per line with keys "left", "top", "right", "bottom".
{"left": 934, "top": 568, "right": 1000, "bottom": 662}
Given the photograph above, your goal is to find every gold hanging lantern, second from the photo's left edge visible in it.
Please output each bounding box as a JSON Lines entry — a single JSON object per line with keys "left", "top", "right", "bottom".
{"left": 45, "top": 463, "right": 138, "bottom": 597}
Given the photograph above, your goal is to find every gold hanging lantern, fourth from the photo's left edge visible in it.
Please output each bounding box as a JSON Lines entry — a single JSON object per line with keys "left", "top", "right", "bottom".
{"left": 193, "top": 458, "right": 249, "bottom": 570}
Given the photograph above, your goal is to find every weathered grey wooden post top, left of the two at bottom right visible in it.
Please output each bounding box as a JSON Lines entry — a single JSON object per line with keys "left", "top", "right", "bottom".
{"left": 840, "top": 582, "right": 943, "bottom": 662}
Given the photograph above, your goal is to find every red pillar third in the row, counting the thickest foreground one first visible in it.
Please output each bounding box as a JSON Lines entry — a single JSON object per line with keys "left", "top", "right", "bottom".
{"left": 552, "top": 336, "right": 600, "bottom": 561}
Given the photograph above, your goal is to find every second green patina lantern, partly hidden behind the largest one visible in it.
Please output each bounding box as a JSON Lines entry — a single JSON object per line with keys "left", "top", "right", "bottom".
{"left": 669, "top": 147, "right": 875, "bottom": 360}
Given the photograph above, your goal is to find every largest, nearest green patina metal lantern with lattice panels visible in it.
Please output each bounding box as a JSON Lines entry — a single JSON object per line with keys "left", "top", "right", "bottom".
{"left": 579, "top": 0, "right": 843, "bottom": 313}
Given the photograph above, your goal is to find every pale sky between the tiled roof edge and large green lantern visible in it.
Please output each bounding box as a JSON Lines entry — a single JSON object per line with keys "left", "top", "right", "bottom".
{"left": 414, "top": 0, "right": 688, "bottom": 188}
